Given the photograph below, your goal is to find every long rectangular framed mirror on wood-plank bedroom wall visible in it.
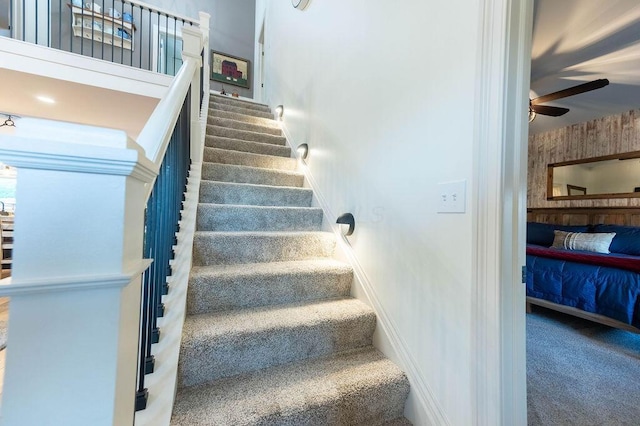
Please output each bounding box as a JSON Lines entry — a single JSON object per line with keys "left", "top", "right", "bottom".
{"left": 547, "top": 151, "right": 640, "bottom": 200}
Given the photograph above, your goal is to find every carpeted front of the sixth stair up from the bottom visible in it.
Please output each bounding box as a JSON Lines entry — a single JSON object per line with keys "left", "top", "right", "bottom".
{"left": 200, "top": 180, "right": 313, "bottom": 207}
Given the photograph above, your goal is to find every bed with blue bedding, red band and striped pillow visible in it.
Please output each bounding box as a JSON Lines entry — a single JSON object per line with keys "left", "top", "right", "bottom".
{"left": 526, "top": 208, "right": 640, "bottom": 333}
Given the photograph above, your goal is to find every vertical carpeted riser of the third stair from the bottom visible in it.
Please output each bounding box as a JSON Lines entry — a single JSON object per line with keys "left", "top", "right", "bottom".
{"left": 187, "top": 268, "right": 353, "bottom": 315}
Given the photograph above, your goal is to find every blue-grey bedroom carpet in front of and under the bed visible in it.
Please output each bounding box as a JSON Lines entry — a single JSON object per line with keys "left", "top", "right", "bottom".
{"left": 527, "top": 306, "right": 640, "bottom": 426}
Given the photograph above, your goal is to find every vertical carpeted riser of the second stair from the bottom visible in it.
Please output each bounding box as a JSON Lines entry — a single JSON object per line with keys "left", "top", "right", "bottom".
{"left": 179, "top": 312, "right": 376, "bottom": 386}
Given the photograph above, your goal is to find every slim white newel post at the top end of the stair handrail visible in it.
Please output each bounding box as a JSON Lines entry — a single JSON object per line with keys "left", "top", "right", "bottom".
{"left": 182, "top": 26, "right": 203, "bottom": 163}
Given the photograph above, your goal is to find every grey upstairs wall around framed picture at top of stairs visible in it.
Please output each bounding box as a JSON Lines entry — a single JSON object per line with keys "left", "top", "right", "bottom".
{"left": 144, "top": 0, "right": 256, "bottom": 98}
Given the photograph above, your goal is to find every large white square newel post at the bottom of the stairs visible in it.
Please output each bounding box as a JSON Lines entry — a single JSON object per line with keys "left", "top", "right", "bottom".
{"left": 0, "top": 118, "right": 156, "bottom": 426}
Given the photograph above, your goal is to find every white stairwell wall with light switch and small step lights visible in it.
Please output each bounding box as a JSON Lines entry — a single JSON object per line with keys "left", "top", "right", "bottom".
{"left": 256, "top": 0, "right": 479, "bottom": 425}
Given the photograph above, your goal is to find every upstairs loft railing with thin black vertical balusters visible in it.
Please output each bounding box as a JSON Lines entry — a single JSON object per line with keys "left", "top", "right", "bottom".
{"left": 5, "top": 0, "right": 199, "bottom": 75}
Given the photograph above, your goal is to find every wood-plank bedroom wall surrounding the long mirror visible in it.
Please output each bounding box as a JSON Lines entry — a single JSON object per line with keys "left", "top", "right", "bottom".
{"left": 527, "top": 110, "right": 640, "bottom": 208}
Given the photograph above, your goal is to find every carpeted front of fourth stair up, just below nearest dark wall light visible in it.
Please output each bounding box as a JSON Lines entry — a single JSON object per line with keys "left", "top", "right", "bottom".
{"left": 193, "top": 231, "right": 336, "bottom": 266}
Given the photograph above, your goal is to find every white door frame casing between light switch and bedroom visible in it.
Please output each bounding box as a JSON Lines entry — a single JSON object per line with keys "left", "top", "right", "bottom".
{"left": 471, "top": 0, "right": 533, "bottom": 426}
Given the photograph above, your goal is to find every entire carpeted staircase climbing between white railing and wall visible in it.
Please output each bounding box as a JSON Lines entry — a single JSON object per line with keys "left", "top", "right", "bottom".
{"left": 171, "top": 95, "right": 410, "bottom": 426}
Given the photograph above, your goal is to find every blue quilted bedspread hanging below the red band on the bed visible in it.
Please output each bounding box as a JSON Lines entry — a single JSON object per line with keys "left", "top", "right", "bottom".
{"left": 527, "top": 245, "right": 640, "bottom": 328}
